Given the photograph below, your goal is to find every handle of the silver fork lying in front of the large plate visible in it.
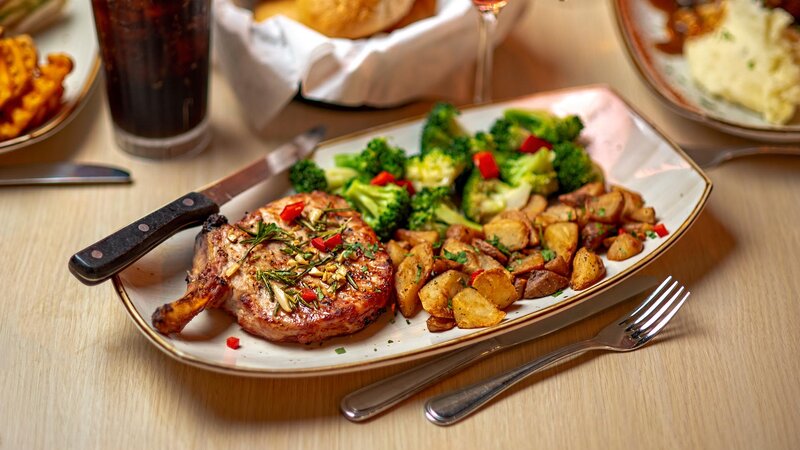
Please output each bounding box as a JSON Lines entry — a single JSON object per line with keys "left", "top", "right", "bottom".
{"left": 425, "top": 341, "right": 598, "bottom": 425}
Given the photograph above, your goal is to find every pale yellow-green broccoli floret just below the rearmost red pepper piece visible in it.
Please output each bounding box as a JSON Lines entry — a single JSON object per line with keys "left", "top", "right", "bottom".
{"left": 500, "top": 148, "right": 558, "bottom": 196}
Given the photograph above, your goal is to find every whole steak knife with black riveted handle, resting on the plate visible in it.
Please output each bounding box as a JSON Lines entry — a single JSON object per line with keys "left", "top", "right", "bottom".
{"left": 69, "top": 126, "right": 325, "bottom": 286}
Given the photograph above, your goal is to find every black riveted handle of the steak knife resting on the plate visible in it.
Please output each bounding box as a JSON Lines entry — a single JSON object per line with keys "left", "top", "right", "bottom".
{"left": 69, "top": 192, "right": 219, "bottom": 286}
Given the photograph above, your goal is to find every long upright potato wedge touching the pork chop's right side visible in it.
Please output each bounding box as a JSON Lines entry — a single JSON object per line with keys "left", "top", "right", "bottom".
{"left": 395, "top": 242, "right": 433, "bottom": 317}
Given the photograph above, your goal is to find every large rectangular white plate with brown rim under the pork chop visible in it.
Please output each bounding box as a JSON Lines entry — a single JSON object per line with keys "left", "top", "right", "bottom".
{"left": 114, "top": 86, "right": 711, "bottom": 377}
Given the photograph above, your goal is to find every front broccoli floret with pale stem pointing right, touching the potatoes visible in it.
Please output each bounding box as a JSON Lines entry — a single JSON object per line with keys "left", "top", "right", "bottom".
{"left": 408, "top": 187, "right": 482, "bottom": 235}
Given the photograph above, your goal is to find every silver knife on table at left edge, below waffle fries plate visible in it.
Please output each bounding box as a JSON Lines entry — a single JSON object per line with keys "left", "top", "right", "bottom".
{"left": 0, "top": 163, "right": 131, "bottom": 186}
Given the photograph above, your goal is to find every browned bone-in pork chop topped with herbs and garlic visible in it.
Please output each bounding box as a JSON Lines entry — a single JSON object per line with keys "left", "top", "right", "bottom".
{"left": 153, "top": 192, "right": 393, "bottom": 343}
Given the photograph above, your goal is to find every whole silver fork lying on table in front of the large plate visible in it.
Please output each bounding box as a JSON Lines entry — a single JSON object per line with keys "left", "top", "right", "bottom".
{"left": 425, "top": 277, "right": 689, "bottom": 425}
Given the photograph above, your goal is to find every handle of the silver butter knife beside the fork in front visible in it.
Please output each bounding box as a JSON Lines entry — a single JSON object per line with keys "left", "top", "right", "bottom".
{"left": 339, "top": 339, "right": 500, "bottom": 422}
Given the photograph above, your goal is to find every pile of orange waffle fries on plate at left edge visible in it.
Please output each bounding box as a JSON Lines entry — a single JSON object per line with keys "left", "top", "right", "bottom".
{"left": 0, "top": 31, "right": 73, "bottom": 140}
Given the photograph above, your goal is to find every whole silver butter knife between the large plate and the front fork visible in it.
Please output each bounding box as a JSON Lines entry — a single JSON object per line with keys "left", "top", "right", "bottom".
{"left": 339, "top": 276, "right": 658, "bottom": 422}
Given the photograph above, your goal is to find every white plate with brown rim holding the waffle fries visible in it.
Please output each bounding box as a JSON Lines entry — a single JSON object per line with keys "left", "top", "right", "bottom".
{"left": 0, "top": 0, "right": 100, "bottom": 154}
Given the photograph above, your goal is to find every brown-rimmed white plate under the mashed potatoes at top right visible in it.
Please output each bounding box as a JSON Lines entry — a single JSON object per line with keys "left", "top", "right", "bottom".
{"left": 614, "top": 0, "right": 800, "bottom": 143}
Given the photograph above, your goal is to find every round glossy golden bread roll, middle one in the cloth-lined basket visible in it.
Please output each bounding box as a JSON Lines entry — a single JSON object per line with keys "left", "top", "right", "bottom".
{"left": 297, "top": 0, "right": 414, "bottom": 39}
